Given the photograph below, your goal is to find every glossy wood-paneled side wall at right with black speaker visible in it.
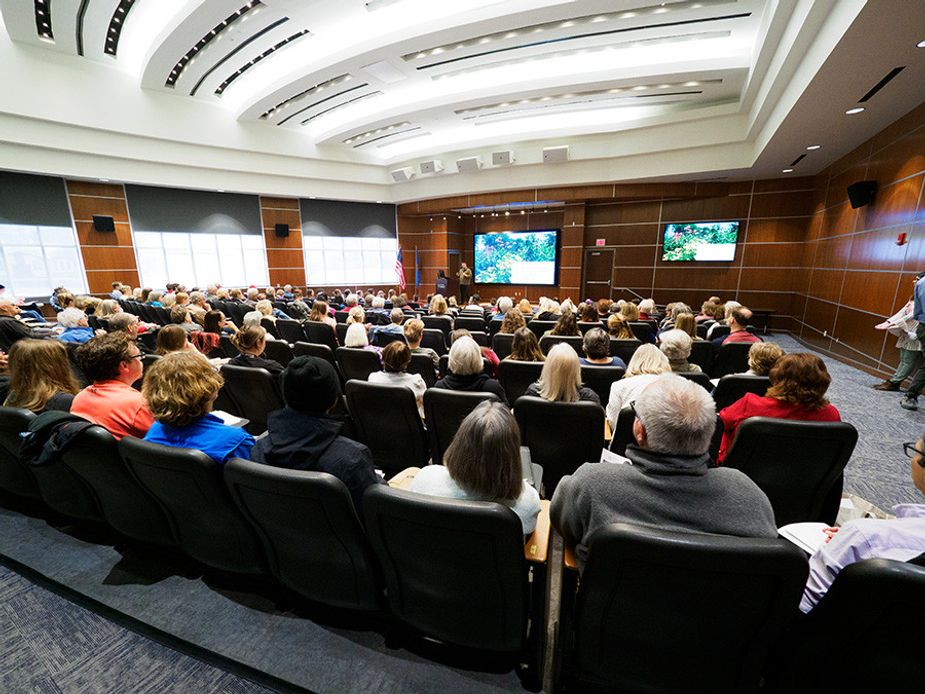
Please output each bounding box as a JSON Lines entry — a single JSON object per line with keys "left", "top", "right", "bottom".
{"left": 794, "top": 104, "right": 925, "bottom": 374}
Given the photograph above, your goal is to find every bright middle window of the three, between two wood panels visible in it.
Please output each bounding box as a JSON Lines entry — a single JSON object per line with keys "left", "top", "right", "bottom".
{"left": 135, "top": 231, "right": 270, "bottom": 288}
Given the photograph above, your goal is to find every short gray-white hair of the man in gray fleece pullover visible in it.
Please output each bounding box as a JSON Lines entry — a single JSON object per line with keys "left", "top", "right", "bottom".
{"left": 635, "top": 374, "right": 716, "bottom": 455}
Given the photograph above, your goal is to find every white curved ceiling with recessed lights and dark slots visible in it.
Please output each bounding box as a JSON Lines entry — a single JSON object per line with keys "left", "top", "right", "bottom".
{"left": 0, "top": 0, "right": 925, "bottom": 201}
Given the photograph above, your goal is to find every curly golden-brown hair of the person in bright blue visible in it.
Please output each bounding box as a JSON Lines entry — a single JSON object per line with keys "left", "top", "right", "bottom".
{"left": 141, "top": 352, "right": 224, "bottom": 427}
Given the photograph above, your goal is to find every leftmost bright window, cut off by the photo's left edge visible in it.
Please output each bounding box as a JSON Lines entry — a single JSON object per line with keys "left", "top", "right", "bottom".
{"left": 0, "top": 224, "right": 87, "bottom": 298}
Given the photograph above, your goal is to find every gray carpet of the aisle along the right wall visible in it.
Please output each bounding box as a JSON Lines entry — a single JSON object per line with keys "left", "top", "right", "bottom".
{"left": 769, "top": 335, "right": 925, "bottom": 511}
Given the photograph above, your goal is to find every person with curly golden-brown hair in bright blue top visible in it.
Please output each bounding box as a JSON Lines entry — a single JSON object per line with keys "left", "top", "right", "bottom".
{"left": 141, "top": 351, "right": 254, "bottom": 465}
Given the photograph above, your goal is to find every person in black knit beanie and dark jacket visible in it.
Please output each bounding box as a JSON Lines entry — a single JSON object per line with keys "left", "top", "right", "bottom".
{"left": 251, "top": 357, "right": 379, "bottom": 510}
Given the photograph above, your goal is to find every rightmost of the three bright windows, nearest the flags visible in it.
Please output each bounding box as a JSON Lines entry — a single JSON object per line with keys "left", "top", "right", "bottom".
{"left": 302, "top": 236, "right": 398, "bottom": 286}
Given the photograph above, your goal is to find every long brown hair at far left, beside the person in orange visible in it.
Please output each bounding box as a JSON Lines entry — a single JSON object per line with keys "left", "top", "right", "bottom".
{"left": 3, "top": 339, "right": 80, "bottom": 414}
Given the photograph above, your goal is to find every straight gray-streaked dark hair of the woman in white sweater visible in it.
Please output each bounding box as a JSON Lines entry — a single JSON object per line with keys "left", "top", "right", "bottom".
{"left": 443, "top": 402, "right": 523, "bottom": 500}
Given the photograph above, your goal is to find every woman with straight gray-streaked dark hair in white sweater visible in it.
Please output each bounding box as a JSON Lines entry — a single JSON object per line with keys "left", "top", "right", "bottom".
{"left": 411, "top": 402, "right": 540, "bottom": 535}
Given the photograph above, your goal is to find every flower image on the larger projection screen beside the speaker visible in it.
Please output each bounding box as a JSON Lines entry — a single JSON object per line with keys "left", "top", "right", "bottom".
{"left": 475, "top": 231, "right": 557, "bottom": 284}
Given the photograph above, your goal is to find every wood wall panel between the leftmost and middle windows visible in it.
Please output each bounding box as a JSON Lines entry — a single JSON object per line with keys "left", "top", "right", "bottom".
{"left": 65, "top": 181, "right": 140, "bottom": 294}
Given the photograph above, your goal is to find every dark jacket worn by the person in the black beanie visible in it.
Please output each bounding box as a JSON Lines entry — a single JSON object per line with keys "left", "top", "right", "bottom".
{"left": 251, "top": 407, "right": 380, "bottom": 513}
